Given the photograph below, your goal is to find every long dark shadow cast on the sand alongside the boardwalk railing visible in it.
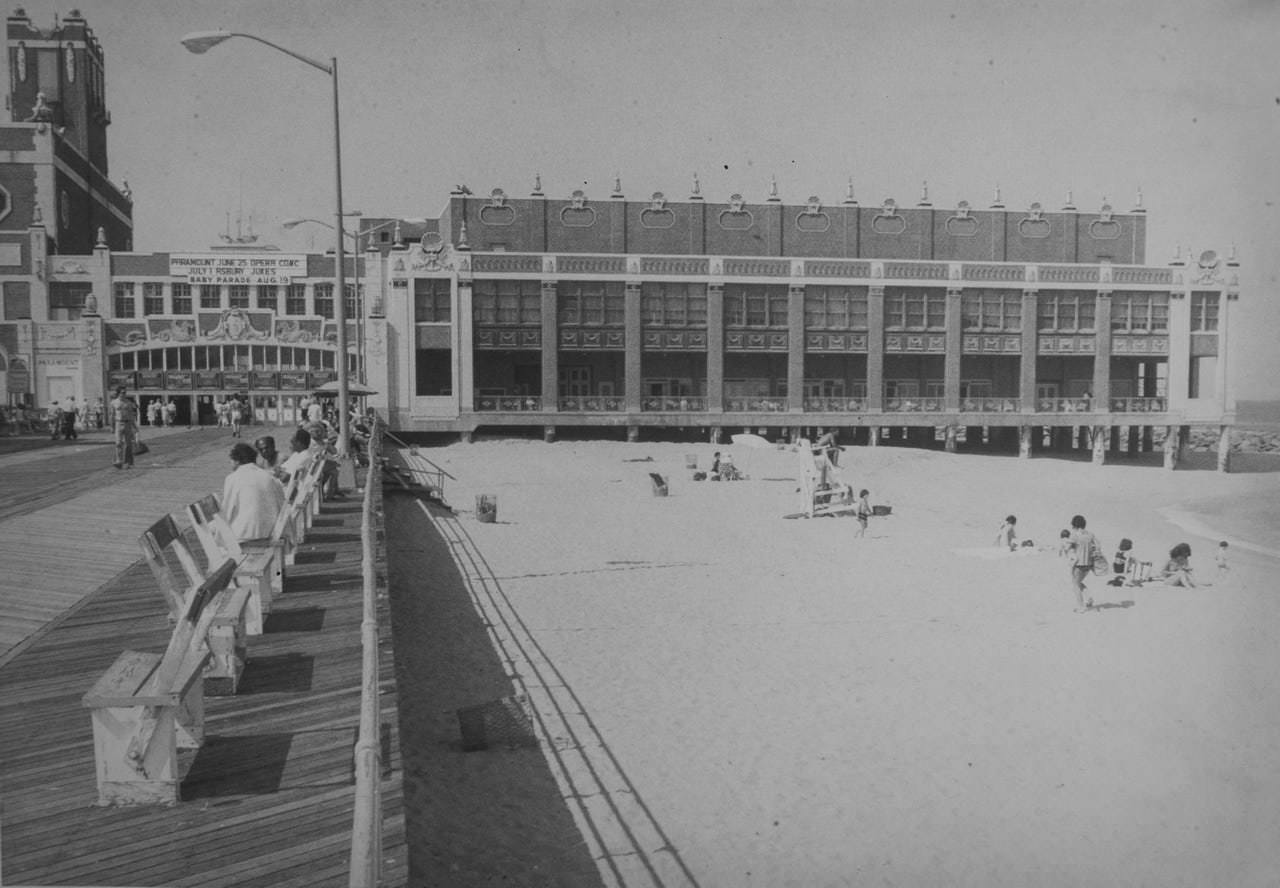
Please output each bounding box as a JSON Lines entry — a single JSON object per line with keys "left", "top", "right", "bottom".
{"left": 384, "top": 494, "right": 603, "bottom": 888}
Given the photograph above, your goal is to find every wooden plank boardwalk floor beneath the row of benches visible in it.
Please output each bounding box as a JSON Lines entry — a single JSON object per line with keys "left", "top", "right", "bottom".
{"left": 0, "top": 431, "right": 407, "bottom": 887}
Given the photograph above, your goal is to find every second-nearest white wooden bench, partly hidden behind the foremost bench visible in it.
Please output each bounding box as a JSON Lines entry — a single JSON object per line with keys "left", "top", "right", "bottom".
{"left": 138, "top": 514, "right": 250, "bottom": 696}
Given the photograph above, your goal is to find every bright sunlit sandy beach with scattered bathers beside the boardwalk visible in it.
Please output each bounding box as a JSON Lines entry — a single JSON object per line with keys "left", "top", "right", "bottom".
{"left": 390, "top": 440, "right": 1280, "bottom": 888}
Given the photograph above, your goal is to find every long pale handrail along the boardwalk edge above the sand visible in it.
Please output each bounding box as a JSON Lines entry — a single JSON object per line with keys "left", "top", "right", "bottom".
{"left": 348, "top": 421, "right": 383, "bottom": 888}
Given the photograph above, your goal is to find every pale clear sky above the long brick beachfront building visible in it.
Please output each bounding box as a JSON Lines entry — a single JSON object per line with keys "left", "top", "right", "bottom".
{"left": 17, "top": 0, "right": 1280, "bottom": 399}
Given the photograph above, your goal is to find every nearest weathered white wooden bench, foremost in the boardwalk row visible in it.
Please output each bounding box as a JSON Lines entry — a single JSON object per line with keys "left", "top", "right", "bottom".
{"left": 82, "top": 560, "right": 236, "bottom": 805}
